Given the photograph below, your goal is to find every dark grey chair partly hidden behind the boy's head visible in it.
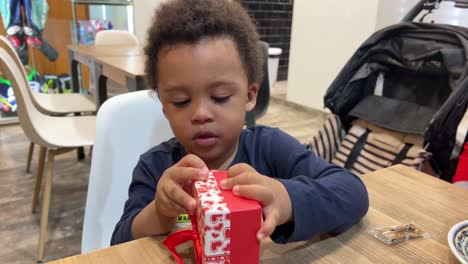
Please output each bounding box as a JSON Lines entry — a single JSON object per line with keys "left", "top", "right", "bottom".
{"left": 245, "top": 41, "right": 270, "bottom": 127}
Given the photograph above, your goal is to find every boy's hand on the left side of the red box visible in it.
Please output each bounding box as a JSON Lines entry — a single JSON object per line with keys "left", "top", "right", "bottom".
{"left": 155, "top": 154, "right": 208, "bottom": 217}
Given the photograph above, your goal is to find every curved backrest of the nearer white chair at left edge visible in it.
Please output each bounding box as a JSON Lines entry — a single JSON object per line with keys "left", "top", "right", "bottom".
{"left": 0, "top": 48, "right": 52, "bottom": 148}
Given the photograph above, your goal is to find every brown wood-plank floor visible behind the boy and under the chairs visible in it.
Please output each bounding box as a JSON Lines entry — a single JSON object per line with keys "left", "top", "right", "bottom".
{"left": 0, "top": 84, "right": 325, "bottom": 263}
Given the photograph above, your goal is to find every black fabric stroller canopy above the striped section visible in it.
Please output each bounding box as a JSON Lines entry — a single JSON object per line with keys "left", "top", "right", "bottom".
{"left": 325, "top": 22, "right": 468, "bottom": 180}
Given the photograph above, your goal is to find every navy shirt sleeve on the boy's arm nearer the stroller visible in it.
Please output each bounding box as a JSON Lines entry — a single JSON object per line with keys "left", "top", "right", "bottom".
{"left": 267, "top": 129, "right": 369, "bottom": 243}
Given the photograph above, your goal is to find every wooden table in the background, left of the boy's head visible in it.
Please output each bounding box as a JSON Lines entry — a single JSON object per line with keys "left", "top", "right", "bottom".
{"left": 68, "top": 45, "right": 145, "bottom": 108}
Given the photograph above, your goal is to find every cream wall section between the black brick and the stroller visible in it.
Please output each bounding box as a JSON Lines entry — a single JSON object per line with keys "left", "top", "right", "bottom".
{"left": 286, "top": 0, "right": 380, "bottom": 109}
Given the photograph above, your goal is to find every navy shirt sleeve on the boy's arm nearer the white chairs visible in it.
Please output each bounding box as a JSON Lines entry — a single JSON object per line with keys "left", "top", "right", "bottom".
{"left": 111, "top": 156, "right": 160, "bottom": 245}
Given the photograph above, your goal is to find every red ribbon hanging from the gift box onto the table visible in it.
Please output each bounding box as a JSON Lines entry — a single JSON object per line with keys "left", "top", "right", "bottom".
{"left": 163, "top": 216, "right": 202, "bottom": 264}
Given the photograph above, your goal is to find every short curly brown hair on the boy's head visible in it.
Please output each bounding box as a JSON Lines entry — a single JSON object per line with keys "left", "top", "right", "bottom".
{"left": 145, "top": 0, "right": 263, "bottom": 91}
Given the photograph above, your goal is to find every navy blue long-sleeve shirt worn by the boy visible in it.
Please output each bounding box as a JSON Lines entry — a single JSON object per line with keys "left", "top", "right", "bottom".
{"left": 111, "top": 126, "right": 369, "bottom": 245}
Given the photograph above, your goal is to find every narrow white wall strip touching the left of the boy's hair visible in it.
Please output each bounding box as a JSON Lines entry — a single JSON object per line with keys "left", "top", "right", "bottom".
{"left": 133, "top": 0, "right": 165, "bottom": 44}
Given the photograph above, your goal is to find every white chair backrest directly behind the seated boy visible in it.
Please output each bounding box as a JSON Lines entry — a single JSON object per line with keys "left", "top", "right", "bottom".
{"left": 81, "top": 90, "right": 173, "bottom": 253}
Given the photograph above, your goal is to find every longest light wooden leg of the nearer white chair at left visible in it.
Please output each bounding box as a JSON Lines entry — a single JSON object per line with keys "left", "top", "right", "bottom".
{"left": 37, "top": 150, "right": 55, "bottom": 261}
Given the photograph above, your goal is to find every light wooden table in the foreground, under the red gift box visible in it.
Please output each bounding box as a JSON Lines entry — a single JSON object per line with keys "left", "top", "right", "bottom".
{"left": 48, "top": 165, "right": 468, "bottom": 264}
